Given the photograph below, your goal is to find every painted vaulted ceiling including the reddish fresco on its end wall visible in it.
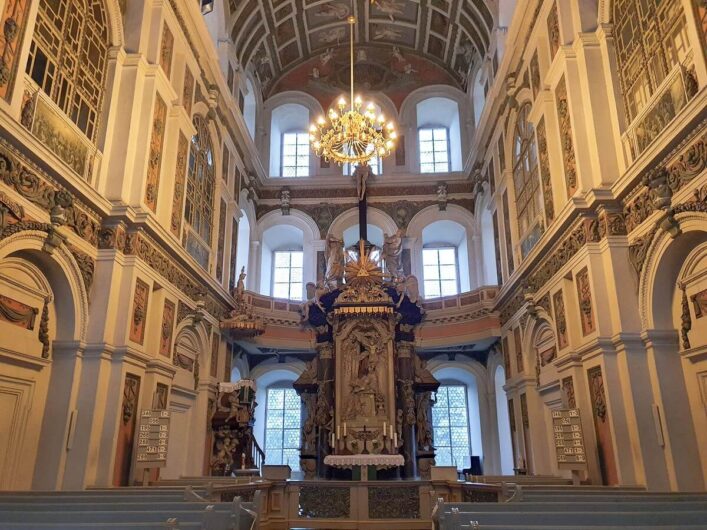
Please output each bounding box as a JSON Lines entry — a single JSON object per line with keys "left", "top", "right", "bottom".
{"left": 228, "top": 0, "right": 494, "bottom": 100}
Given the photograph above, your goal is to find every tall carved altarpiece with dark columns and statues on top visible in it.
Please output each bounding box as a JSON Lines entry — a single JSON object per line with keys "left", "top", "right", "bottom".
{"left": 294, "top": 241, "right": 439, "bottom": 478}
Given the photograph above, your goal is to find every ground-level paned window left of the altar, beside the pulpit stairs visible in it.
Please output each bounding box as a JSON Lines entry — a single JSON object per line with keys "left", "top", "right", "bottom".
{"left": 265, "top": 388, "right": 301, "bottom": 471}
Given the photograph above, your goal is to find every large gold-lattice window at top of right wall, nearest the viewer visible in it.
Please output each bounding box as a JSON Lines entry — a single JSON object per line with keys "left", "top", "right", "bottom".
{"left": 613, "top": 0, "right": 690, "bottom": 122}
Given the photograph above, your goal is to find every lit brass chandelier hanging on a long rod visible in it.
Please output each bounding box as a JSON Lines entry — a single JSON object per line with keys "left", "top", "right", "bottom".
{"left": 309, "top": 16, "right": 398, "bottom": 165}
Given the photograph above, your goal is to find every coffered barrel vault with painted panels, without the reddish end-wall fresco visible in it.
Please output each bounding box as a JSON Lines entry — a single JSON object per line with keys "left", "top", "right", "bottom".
{"left": 228, "top": 0, "right": 494, "bottom": 97}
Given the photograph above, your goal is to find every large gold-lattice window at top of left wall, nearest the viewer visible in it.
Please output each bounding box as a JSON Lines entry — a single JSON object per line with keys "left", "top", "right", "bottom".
{"left": 27, "top": 0, "right": 109, "bottom": 140}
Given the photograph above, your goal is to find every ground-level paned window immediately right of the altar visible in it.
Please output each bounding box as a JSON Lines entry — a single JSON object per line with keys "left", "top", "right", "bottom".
{"left": 432, "top": 385, "right": 471, "bottom": 469}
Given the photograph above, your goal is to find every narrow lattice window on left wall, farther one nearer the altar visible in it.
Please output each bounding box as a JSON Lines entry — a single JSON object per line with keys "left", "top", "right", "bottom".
{"left": 184, "top": 114, "right": 215, "bottom": 269}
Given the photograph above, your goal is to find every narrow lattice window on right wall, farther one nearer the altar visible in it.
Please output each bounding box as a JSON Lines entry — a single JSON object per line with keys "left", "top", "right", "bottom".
{"left": 513, "top": 104, "right": 542, "bottom": 257}
